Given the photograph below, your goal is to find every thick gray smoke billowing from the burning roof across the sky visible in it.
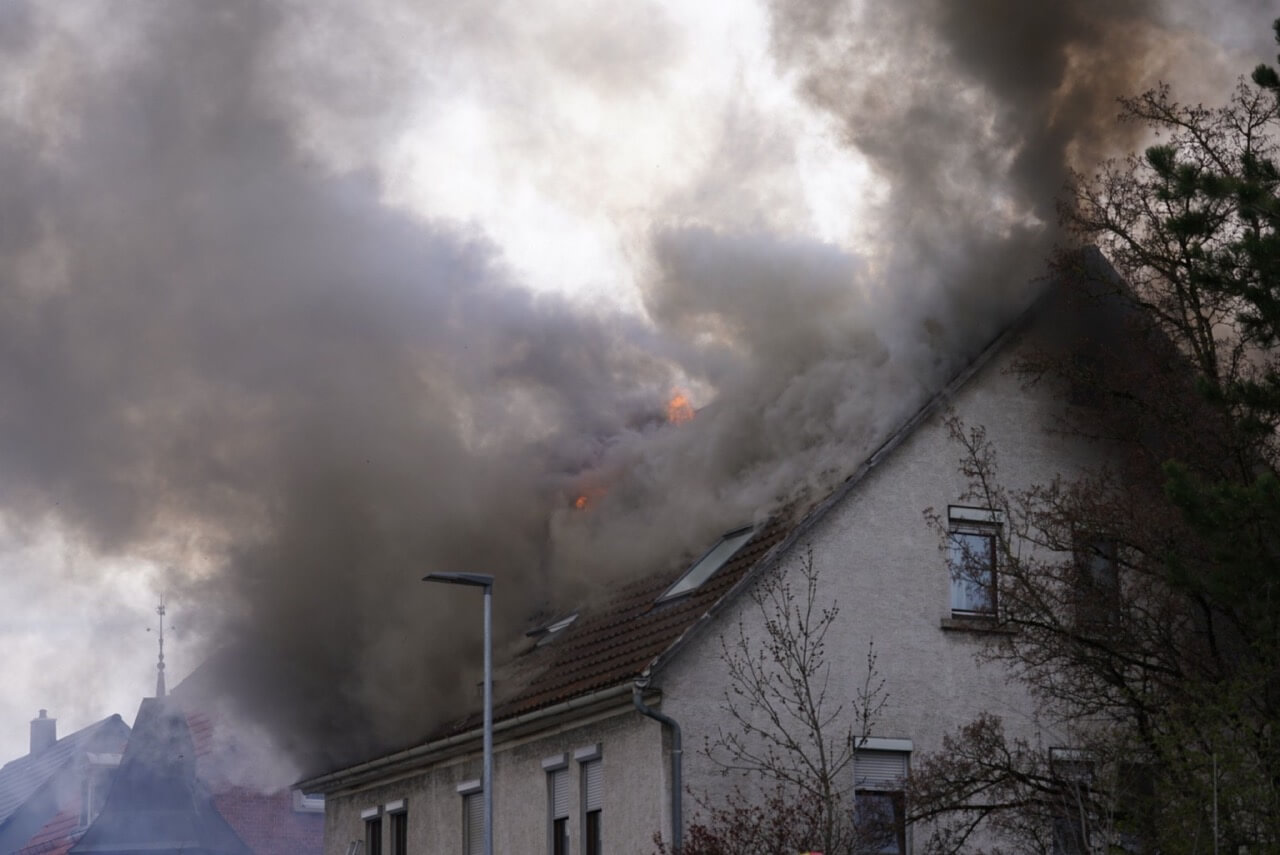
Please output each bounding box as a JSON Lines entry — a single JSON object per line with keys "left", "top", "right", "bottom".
{"left": 0, "top": 0, "right": 1264, "bottom": 768}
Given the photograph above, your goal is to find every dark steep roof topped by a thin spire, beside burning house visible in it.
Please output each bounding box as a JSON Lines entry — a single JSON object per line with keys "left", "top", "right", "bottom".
{"left": 70, "top": 698, "right": 250, "bottom": 855}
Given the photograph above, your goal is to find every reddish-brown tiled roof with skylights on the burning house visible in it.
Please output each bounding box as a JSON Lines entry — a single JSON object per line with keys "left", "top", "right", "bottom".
{"left": 300, "top": 252, "right": 1080, "bottom": 791}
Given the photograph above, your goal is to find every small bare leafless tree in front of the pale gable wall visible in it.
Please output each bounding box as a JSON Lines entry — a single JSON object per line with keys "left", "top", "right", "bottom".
{"left": 659, "top": 550, "right": 896, "bottom": 855}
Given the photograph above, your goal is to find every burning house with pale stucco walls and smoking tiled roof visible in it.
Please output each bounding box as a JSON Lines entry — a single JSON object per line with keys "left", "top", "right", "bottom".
{"left": 294, "top": 270, "right": 1116, "bottom": 855}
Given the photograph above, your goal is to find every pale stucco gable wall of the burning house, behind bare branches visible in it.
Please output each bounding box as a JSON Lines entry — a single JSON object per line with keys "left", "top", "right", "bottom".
{"left": 655, "top": 327, "right": 1097, "bottom": 834}
